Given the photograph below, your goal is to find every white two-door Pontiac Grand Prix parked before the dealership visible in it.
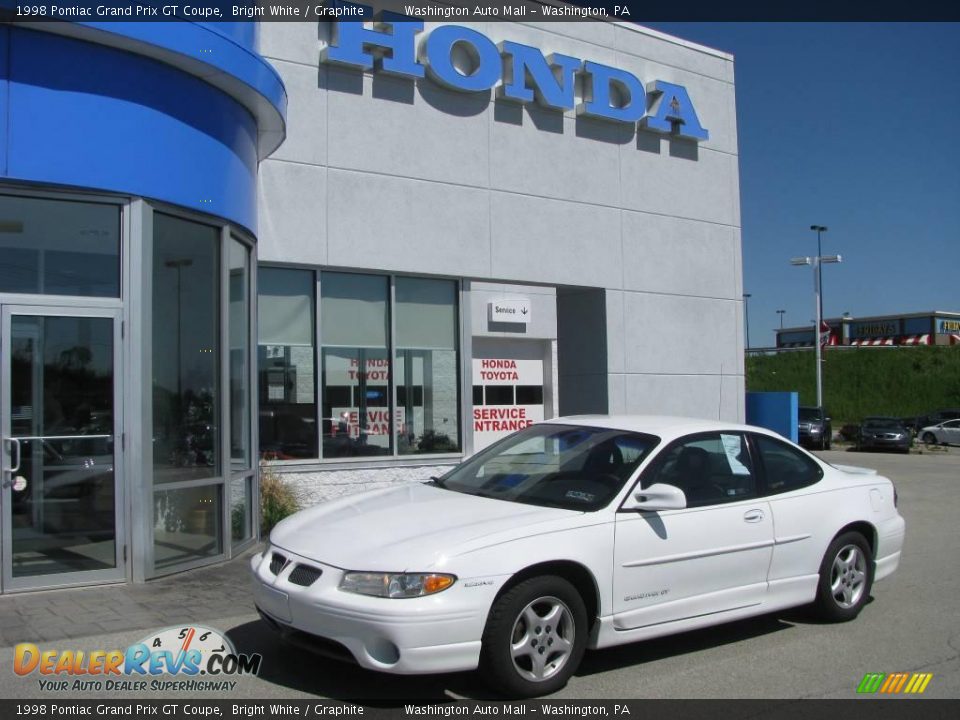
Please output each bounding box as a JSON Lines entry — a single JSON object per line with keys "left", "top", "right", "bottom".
{"left": 251, "top": 417, "right": 904, "bottom": 697}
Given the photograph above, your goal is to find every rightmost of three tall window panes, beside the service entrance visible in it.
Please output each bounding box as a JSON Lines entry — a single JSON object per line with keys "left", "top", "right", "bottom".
{"left": 395, "top": 277, "right": 460, "bottom": 455}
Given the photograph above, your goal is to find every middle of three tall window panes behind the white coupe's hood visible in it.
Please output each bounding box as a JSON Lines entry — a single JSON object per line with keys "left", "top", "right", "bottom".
{"left": 320, "top": 273, "right": 393, "bottom": 458}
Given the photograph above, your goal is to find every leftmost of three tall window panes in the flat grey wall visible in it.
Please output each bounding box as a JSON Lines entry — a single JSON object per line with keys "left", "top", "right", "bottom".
{"left": 258, "top": 268, "right": 318, "bottom": 460}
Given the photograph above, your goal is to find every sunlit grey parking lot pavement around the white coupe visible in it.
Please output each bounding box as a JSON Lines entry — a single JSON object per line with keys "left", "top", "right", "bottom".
{"left": 0, "top": 448, "right": 960, "bottom": 704}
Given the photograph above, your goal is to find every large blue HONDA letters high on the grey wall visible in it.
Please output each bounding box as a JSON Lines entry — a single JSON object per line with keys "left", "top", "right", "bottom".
{"left": 320, "top": 3, "right": 710, "bottom": 142}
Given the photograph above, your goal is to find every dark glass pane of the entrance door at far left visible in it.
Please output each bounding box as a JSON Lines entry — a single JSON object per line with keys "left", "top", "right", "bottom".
{"left": 10, "top": 315, "right": 116, "bottom": 577}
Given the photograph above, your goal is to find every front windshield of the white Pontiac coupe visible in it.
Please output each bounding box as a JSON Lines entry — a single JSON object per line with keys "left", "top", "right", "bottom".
{"left": 433, "top": 424, "right": 660, "bottom": 511}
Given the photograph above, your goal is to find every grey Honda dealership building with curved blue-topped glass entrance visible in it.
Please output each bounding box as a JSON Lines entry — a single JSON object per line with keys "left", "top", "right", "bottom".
{"left": 0, "top": 7, "right": 744, "bottom": 593}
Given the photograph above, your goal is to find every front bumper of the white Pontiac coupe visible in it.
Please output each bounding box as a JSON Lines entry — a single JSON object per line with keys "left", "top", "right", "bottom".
{"left": 250, "top": 549, "right": 500, "bottom": 675}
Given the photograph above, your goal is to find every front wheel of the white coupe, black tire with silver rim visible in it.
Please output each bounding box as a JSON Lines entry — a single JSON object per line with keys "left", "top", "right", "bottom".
{"left": 480, "top": 575, "right": 588, "bottom": 698}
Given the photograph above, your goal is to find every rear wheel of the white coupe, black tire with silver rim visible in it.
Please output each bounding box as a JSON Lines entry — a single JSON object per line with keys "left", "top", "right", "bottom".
{"left": 813, "top": 532, "right": 873, "bottom": 622}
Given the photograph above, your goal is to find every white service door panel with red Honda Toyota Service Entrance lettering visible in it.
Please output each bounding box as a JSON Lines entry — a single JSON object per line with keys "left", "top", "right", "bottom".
{"left": 473, "top": 358, "right": 544, "bottom": 450}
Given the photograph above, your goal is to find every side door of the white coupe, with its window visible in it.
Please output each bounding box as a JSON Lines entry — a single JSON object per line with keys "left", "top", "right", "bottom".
{"left": 613, "top": 432, "right": 773, "bottom": 630}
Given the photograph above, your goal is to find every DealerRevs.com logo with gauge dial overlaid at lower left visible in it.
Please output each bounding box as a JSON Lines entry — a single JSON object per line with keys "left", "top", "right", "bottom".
{"left": 13, "top": 625, "right": 263, "bottom": 692}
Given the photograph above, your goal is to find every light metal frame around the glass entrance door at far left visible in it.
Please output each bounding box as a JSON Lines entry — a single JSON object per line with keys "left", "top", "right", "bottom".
{"left": 0, "top": 304, "right": 128, "bottom": 593}
